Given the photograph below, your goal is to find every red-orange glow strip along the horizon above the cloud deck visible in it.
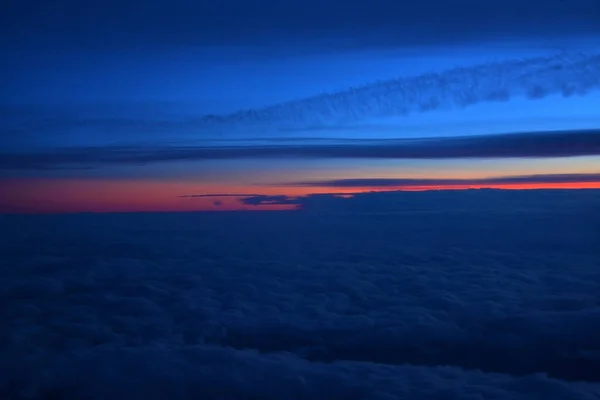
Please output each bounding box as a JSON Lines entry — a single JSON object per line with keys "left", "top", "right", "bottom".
{"left": 0, "top": 179, "right": 600, "bottom": 214}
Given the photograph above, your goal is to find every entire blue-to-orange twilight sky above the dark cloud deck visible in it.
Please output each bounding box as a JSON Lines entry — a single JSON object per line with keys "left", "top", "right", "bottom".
{"left": 0, "top": 0, "right": 600, "bottom": 213}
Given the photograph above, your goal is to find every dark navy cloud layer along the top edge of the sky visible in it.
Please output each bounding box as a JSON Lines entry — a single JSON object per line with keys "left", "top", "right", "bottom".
{"left": 1, "top": 0, "right": 600, "bottom": 51}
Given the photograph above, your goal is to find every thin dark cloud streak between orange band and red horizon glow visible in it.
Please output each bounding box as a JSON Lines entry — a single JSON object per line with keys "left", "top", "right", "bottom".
{"left": 278, "top": 173, "right": 600, "bottom": 188}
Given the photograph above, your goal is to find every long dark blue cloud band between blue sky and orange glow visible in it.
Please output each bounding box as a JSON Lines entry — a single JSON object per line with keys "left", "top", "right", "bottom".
{"left": 0, "top": 129, "right": 600, "bottom": 170}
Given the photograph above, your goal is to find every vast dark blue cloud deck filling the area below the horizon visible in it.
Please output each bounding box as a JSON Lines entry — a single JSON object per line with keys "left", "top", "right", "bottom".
{"left": 0, "top": 191, "right": 600, "bottom": 400}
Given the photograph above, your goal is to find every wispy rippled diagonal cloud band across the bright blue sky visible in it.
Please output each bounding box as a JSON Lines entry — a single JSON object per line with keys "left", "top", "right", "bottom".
{"left": 193, "top": 50, "right": 600, "bottom": 133}
